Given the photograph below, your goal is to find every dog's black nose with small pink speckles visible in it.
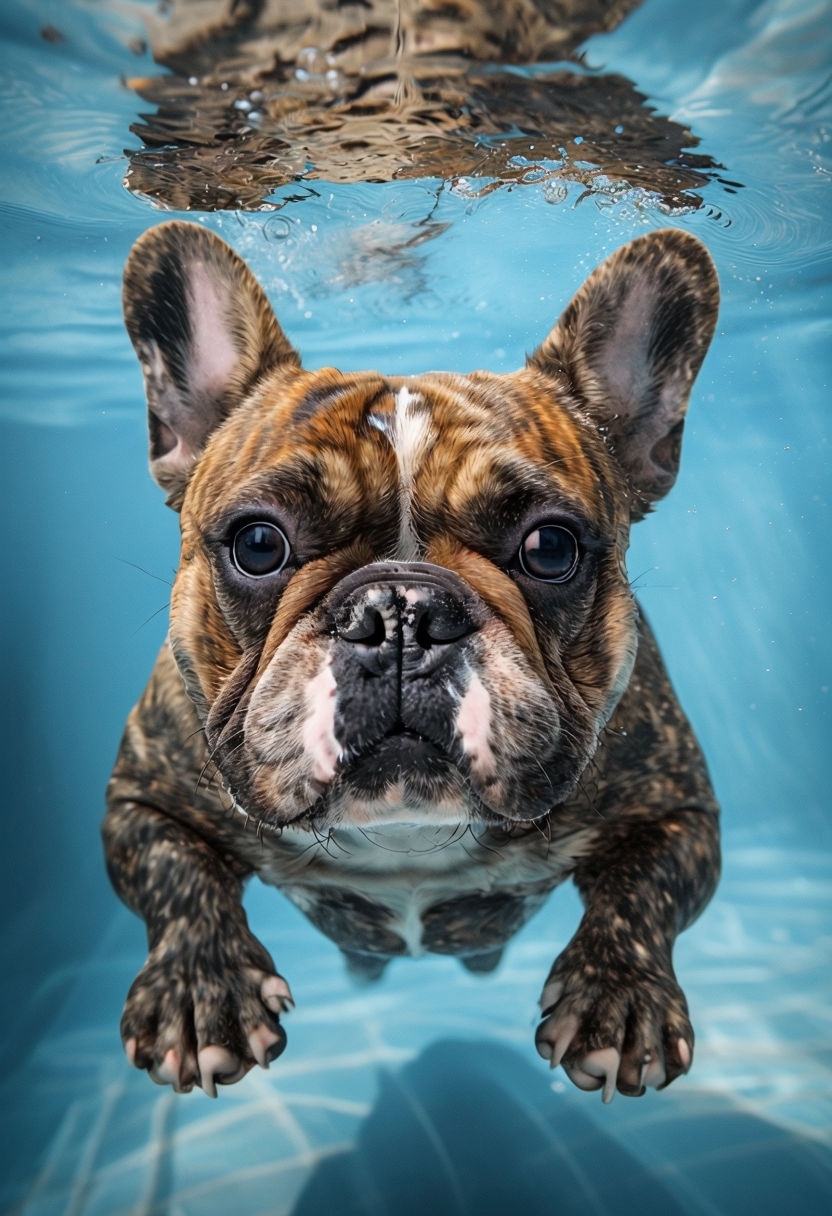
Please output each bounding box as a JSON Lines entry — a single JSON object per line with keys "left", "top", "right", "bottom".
{"left": 330, "top": 563, "right": 479, "bottom": 675}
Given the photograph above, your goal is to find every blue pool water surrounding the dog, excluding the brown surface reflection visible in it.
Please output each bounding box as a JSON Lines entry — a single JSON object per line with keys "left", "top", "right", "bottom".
{"left": 0, "top": 0, "right": 832, "bottom": 1216}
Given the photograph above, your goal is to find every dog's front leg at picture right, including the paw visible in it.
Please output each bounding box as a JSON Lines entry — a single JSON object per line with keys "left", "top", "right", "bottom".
{"left": 536, "top": 810, "right": 719, "bottom": 1102}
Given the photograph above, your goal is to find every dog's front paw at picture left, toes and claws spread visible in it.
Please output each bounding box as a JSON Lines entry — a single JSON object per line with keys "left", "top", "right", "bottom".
{"left": 122, "top": 927, "right": 293, "bottom": 1098}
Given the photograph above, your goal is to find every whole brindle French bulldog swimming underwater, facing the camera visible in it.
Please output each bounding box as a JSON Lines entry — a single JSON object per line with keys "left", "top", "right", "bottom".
{"left": 103, "top": 223, "right": 719, "bottom": 1099}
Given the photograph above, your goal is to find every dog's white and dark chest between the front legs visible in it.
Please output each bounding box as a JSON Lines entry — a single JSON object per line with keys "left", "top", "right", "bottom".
{"left": 258, "top": 824, "right": 590, "bottom": 958}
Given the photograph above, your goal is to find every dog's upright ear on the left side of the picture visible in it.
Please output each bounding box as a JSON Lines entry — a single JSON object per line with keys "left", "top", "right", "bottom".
{"left": 123, "top": 221, "right": 295, "bottom": 507}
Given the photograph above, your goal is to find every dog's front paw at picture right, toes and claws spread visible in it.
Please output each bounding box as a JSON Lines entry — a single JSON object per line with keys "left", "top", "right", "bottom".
{"left": 535, "top": 942, "right": 693, "bottom": 1102}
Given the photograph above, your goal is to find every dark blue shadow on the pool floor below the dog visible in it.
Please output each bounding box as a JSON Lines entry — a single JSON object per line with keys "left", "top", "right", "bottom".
{"left": 293, "top": 1041, "right": 832, "bottom": 1216}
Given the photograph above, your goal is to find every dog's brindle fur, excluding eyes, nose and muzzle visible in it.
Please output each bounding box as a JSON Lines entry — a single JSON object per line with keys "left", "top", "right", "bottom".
{"left": 103, "top": 224, "right": 719, "bottom": 1097}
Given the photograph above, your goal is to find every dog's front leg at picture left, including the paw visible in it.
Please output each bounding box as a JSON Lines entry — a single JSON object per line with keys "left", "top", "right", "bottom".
{"left": 103, "top": 801, "right": 292, "bottom": 1097}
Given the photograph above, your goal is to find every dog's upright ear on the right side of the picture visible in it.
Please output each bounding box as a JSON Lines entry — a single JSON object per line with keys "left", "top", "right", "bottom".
{"left": 528, "top": 229, "right": 719, "bottom": 518}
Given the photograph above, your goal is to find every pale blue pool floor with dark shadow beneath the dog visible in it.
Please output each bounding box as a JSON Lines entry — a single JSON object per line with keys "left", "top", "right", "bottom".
{"left": 6, "top": 848, "right": 832, "bottom": 1216}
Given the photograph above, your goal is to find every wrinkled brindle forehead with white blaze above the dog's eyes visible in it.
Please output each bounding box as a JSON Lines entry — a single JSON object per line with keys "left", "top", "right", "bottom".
{"left": 191, "top": 368, "right": 613, "bottom": 528}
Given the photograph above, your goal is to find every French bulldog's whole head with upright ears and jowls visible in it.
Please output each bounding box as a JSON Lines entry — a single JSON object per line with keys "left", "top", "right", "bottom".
{"left": 124, "top": 223, "right": 718, "bottom": 831}
